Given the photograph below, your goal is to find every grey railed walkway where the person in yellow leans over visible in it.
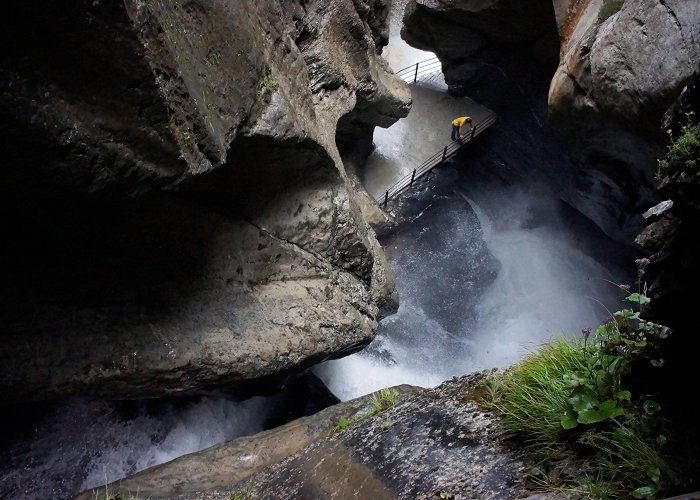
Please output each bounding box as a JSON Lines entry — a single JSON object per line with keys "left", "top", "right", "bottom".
{"left": 363, "top": 58, "right": 496, "bottom": 205}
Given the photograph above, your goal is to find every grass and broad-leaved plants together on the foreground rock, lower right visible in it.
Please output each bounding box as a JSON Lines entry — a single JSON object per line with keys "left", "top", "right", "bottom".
{"left": 482, "top": 259, "right": 673, "bottom": 498}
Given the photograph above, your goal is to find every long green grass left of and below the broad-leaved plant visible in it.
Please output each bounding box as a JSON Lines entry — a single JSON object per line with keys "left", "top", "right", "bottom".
{"left": 483, "top": 340, "right": 668, "bottom": 498}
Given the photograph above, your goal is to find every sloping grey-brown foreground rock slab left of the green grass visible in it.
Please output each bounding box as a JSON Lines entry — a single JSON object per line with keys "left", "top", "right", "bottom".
{"left": 79, "top": 374, "right": 527, "bottom": 500}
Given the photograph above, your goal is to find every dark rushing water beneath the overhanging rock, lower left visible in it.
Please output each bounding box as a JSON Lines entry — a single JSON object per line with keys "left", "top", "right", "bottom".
{"left": 0, "top": 397, "right": 274, "bottom": 499}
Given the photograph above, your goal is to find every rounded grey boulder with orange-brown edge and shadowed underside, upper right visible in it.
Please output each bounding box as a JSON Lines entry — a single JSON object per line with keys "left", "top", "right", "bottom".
{"left": 549, "top": 0, "right": 700, "bottom": 181}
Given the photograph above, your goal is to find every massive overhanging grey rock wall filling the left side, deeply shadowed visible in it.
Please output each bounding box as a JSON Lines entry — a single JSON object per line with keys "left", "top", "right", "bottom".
{"left": 0, "top": 0, "right": 410, "bottom": 400}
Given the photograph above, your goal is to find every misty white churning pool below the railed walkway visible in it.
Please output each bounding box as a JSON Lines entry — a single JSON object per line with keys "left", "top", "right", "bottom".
{"left": 317, "top": 171, "right": 617, "bottom": 400}
